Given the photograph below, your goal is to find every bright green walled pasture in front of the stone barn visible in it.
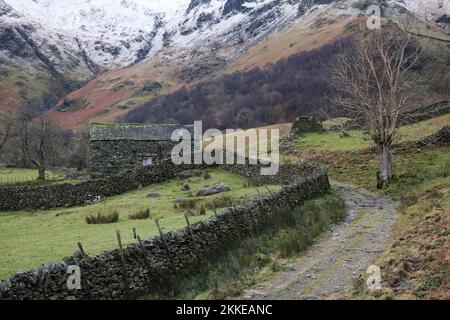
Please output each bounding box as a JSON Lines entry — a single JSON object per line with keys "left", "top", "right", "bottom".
{"left": 0, "top": 170, "right": 279, "bottom": 278}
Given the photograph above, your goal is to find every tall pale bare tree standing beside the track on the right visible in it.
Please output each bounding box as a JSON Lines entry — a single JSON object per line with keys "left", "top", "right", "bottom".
{"left": 331, "top": 21, "right": 423, "bottom": 188}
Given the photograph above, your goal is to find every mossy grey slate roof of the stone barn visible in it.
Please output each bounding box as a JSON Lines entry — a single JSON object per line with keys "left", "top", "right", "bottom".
{"left": 89, "top": 123, "right": 194, "bottom": 141}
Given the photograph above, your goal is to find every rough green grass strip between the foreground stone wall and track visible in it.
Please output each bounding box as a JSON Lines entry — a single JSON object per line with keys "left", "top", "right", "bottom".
{"left": 163, "top": 194, "right": 345, "bottom": 300}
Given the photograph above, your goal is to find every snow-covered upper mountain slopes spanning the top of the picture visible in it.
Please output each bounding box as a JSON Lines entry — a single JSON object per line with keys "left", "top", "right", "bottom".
{"left": 2, "top": 0, "right": 450, "bottom": 69}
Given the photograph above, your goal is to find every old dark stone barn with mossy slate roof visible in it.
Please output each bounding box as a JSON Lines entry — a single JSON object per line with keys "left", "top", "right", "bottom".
{"left": 89, "top": 123, "right": 194, "bottom": 178}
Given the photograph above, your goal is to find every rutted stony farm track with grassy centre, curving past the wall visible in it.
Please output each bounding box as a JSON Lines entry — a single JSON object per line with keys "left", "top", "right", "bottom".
{"left": 245, "top": 184, "right": 397, "bottom": 300}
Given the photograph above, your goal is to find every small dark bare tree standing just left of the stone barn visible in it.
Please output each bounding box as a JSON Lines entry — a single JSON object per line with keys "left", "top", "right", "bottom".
{"left": 16, "top": 117, "right": 61, "bottom": 180}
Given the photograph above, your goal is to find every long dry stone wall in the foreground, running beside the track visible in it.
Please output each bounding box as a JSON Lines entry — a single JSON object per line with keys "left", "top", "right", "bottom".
{"left": 0, "top": 163, "right": 330, "bottom": 299}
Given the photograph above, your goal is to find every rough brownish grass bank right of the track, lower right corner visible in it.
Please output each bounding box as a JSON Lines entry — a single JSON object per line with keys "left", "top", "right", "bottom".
{"left": 350, "top": 177, "right": 450, "bottom": 300}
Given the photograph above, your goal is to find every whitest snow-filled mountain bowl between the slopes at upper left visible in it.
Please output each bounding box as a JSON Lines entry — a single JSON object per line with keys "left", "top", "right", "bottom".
{"left": 5, "top": 0, "right": 189, "bottom": 67}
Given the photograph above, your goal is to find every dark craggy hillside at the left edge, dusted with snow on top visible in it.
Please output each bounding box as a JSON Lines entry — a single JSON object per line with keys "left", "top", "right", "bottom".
{"left": 0, "top": 0, "right": 96, "bottom": 111}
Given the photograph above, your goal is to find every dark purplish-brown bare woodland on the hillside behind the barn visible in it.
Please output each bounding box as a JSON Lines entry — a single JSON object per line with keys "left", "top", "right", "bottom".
{"left": 120, "top": 38, "right": 352, "bottom": 129}
